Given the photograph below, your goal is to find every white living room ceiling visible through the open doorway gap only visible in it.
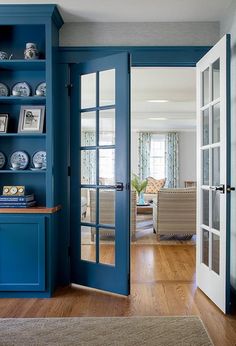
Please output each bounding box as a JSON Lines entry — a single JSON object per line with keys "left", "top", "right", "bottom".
{"left": 131, "top": 67, "right": 196, "bottom": 131}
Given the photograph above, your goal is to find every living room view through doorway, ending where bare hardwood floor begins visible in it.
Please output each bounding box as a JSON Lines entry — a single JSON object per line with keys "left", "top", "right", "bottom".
{"left": 131, "top": 67, "right": 197, "bottom": 245}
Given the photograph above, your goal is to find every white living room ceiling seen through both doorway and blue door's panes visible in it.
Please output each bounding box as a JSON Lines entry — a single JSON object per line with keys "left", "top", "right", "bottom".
{"left": 82, "top": 67, "right": 196, "bottom": 132}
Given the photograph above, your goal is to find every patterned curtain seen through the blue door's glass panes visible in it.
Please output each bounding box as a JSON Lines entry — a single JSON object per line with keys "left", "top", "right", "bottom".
{"left": 81, "top": 132, "right": 96, "bottom": 184}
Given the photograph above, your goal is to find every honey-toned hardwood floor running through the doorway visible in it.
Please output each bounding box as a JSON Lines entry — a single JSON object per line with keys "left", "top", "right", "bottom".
{"left": 0, "top": 245, "right": 236, "bottom": 346}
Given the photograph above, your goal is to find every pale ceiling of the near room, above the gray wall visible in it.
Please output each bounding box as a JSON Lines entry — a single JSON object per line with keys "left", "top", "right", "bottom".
{"left": 0, "top": 0, "right": 234, "bottom": 22}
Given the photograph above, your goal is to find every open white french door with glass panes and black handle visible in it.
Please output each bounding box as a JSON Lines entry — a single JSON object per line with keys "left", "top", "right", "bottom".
{"left": 197, "top": 35, "right": 231, "bottom": 313}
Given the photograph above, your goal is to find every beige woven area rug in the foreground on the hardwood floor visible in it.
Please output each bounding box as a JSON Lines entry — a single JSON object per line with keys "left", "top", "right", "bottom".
{"left": 0, "top": 316, "right": 213, "bottom": 346}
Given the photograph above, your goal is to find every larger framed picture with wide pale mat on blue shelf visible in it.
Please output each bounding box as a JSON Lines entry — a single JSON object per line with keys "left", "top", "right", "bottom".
{"left": 18, "top": 106, "right": 45, "bottom": 133}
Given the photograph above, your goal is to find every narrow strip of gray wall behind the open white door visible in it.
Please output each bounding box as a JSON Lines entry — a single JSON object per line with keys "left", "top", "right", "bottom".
{"left": 221, "top": 2, "right": 236, "bottom": 290}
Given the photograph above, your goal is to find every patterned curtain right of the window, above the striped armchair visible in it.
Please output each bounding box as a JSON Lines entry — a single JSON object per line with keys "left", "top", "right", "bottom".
{"left": 165, "top": 132, "right": 179, "bottom": 188}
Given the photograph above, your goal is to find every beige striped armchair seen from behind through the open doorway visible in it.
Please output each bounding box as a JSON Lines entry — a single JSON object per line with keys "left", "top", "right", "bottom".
{"left": 153, "top": 188, "right": 196, "bottom": 236}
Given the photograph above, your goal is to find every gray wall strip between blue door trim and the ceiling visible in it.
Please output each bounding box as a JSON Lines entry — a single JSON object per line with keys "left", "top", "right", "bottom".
{"left": 60, "top": 22, "right": 220, "bottom": 46}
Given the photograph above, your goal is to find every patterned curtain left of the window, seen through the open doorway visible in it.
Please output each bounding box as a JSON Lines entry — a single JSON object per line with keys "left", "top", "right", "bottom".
{"left": 138, "top": 132, "right": 152, "bottom": 179}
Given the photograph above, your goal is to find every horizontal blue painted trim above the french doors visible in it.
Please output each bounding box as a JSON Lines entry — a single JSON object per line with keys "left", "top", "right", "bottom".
{"left": 58, "top": 46, "right": 211, "bottom": 67}
